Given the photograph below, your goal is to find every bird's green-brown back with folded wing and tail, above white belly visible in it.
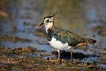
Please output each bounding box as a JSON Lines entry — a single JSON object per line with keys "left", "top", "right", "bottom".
{"left": 53, "top": 28, "right": 96, "bottom": 46}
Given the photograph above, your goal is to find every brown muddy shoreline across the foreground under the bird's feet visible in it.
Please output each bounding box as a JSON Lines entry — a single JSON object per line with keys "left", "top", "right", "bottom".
{"left": 0, "top": 47, "right": 103, "bottom": 71}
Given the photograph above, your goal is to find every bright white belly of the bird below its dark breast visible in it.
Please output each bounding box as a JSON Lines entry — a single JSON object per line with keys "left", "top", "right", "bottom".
{"left": 48, "top": 37, "right": 70, "bottom": 50}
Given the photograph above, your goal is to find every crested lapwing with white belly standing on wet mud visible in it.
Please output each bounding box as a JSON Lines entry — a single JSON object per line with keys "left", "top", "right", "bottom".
{"left": 40, "top": 12, "right": 96, "bottom": 62}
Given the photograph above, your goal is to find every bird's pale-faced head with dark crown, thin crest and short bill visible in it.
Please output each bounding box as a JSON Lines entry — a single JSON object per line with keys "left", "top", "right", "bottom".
{"left": 40, "top": 12, "right": 57, "bottom": 31}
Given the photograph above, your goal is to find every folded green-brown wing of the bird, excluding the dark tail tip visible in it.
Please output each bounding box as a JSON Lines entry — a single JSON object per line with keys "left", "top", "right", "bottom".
{"left": 54, "top": 29, "right": 93, "bottom": 46}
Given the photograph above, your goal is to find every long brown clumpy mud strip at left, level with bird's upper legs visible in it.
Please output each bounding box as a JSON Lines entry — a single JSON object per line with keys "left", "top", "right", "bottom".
{"left": 1, "top": 46, "right": 45, "bottom": 55}
